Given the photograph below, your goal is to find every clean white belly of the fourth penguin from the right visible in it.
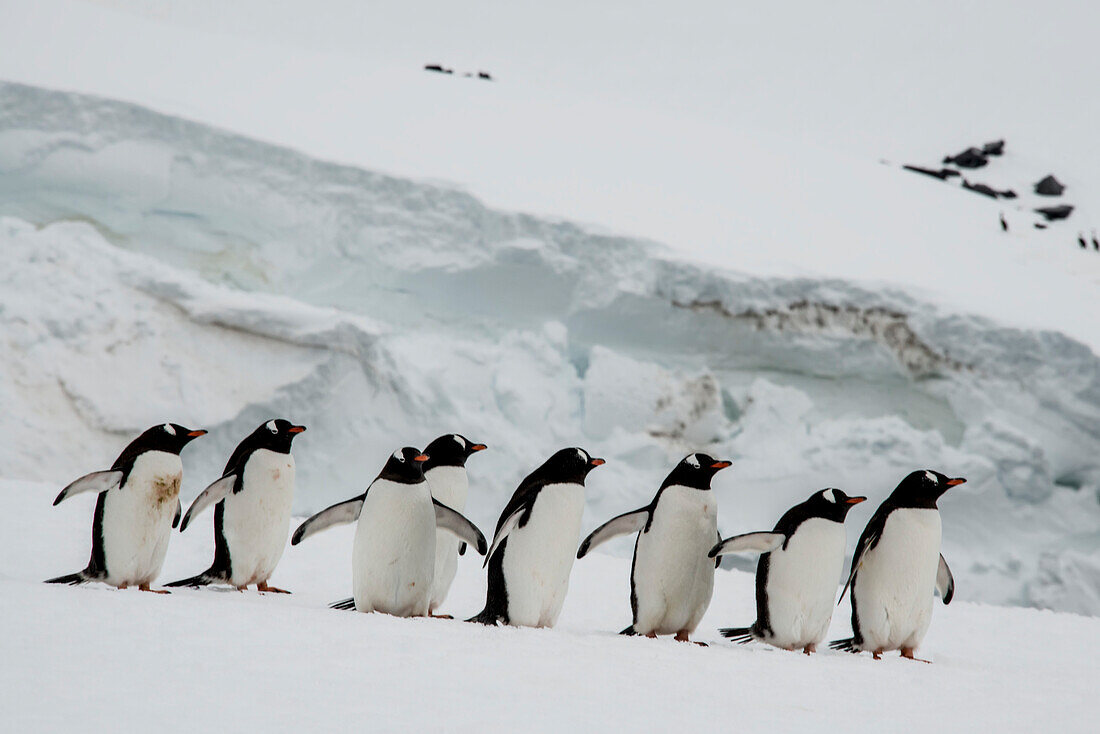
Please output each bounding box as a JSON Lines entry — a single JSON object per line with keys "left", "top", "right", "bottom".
{"left": 502, "top": 484, "right": 584, "bottom": 627}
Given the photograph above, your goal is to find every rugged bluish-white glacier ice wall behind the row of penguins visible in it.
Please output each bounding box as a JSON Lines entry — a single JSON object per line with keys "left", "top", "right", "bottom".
{"left": 0, "top": 84, "right": 1100, "bottom": 614}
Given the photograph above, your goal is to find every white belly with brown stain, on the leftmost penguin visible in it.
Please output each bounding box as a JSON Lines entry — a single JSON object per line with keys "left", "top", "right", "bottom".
{"left": 101, "top": 451, "right": 184, "bottom": 587}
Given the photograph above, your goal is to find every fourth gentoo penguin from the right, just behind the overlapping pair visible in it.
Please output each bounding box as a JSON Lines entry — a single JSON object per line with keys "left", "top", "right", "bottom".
{"left": 468, "top": 448, "right": 604, "bottom": 627}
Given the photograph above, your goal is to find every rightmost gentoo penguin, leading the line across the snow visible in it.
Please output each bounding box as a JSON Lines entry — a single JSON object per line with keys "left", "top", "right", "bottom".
{"left": 829, "top": 471, "right": 966, "bottom": 660}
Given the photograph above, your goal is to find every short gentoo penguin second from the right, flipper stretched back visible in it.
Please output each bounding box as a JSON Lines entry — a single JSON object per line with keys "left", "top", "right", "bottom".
{"left": 711, "top": 489, "right": 867, "bottom": 655}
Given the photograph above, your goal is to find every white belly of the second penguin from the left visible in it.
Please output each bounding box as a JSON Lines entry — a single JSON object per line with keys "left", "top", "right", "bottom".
{"left": 222, "top": 449, "right": 295, "bottom": 587}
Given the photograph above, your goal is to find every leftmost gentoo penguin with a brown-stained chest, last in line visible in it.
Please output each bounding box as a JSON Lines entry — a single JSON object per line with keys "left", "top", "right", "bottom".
{"left": 46, "top": 423, "right": 206, "bottom": 594}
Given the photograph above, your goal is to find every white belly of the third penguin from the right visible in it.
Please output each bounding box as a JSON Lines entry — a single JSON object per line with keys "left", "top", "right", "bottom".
{"left": 633, "top": 486, "right": 718, "bottom": 635}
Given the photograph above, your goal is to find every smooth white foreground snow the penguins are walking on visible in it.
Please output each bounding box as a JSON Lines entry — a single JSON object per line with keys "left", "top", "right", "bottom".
{"left": 0, "top": 481, "right": 1100, "bottom": 734}
